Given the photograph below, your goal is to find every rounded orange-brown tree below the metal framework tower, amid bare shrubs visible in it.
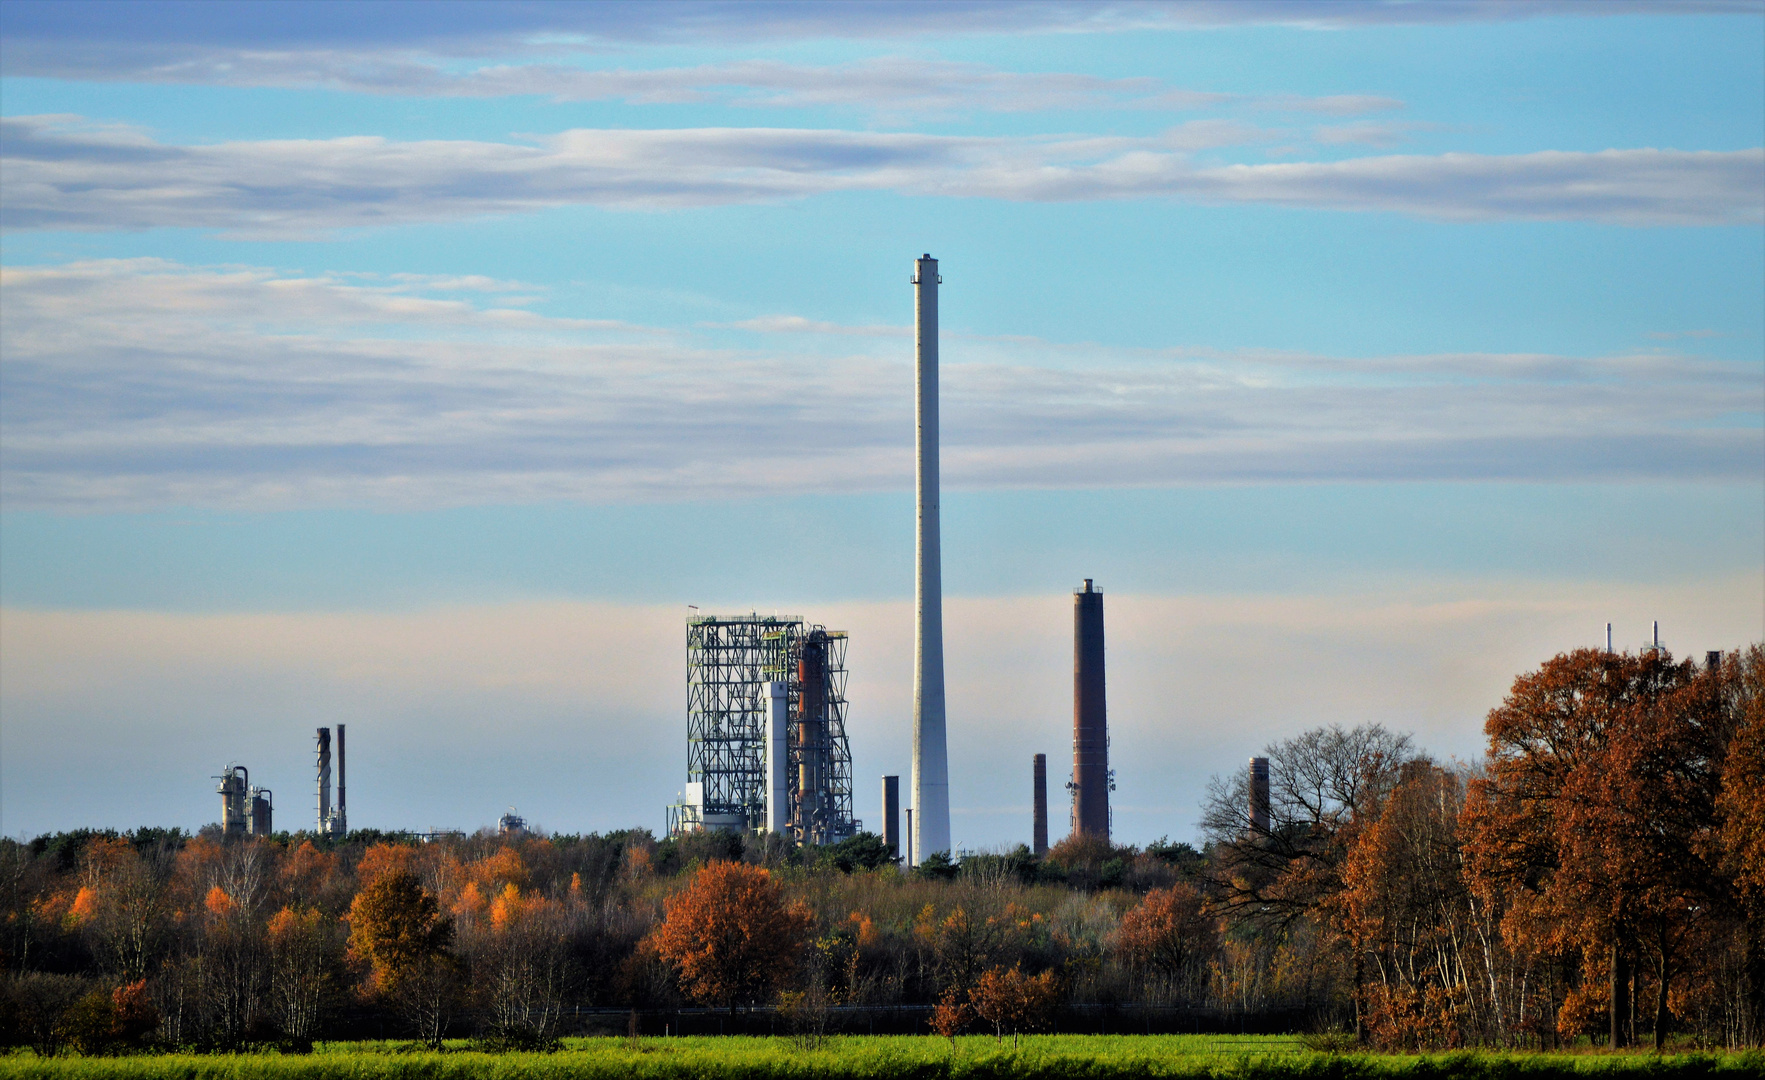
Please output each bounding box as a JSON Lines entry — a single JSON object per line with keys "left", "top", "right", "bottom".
{"left": 653, "top": 861, "right": 814, "bottom": 1015}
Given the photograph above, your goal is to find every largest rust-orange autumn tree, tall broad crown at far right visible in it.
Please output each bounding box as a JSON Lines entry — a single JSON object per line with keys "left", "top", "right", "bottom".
{"left": 1463, "top": 649, "right": 1728, "bottom": 1046}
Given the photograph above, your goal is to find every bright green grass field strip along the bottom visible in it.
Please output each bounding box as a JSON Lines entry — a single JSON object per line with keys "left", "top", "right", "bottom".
{"left": 0, "top": 1036, "right": 1765, "bottom": 1080}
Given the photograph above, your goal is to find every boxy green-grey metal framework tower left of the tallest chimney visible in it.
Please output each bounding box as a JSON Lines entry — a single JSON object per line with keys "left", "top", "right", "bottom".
{"left": 667, "top": 614, "right": 860, "bottom": 844}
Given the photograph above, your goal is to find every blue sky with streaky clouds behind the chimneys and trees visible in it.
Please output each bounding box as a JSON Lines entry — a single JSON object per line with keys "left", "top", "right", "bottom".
{"left": 0, "top": 0, "right": 1765, "bottom": 851}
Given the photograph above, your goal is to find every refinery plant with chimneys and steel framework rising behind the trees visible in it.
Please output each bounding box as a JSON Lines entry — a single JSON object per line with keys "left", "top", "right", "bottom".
{"left": 196, "top": 254, "right": 1129, "bottom": 865}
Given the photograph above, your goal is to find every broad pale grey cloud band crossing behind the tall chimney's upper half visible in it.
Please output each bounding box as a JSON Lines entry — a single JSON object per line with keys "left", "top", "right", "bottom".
{"left": 0, "top": 261, "right": 1761, "bottom": 510}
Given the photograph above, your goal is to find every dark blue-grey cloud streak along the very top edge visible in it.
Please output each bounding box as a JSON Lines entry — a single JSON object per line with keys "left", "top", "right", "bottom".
{"left": 4, "top": 0, "right": 1760, "bottom": 63}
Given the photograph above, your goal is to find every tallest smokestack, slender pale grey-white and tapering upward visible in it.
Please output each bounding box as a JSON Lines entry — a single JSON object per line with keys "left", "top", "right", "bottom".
{"left": 907, "top": 254, "right": 950, "bottom": 865}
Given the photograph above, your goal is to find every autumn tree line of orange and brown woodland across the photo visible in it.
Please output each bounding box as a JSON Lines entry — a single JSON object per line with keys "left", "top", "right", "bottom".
{"left": 0, "top": 646, "right": 1765, "bottom": 1054}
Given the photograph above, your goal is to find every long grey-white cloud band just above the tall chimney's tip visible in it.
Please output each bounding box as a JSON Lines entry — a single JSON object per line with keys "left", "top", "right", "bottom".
{"left": 0, "top": 118, "right": 1765, "bottom": 229}
